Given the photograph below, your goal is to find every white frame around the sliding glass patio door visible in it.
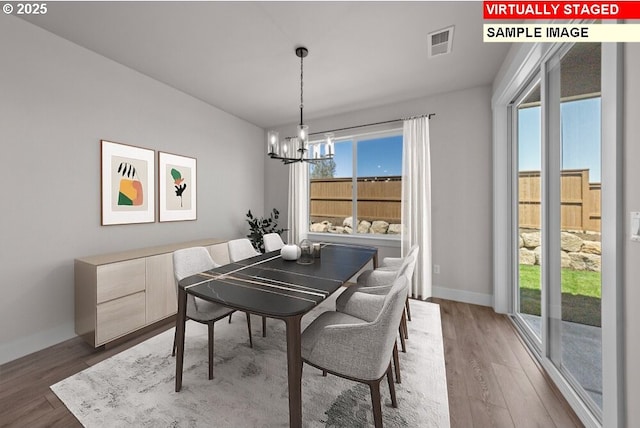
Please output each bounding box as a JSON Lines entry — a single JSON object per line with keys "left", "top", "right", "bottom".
{"left": 492, "top": 38, "right": 625, "bottom": 427}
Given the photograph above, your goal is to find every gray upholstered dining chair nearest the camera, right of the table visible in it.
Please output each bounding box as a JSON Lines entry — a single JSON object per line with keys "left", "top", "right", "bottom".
{"left": 301, "top": 275, "right": 409, "bottom": 428}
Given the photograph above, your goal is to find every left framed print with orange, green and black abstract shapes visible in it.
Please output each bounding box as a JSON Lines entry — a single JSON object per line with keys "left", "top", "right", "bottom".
{"left": 100, "top": 140, "right": 156, "bottom": 226}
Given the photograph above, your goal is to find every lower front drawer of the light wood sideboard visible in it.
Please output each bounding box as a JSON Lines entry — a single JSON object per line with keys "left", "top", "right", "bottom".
{"left": 96, "top": 292, "right": 145, "bottom": 346}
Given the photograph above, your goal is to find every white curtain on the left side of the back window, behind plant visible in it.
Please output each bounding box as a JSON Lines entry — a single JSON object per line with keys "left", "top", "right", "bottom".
{"left": 287, "top": 162, "right": 309, "bottom": 244}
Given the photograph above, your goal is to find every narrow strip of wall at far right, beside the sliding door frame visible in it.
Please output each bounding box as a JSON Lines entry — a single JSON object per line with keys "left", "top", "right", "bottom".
{"left": 624, "top": 43, "right": 640, "bottom": 427}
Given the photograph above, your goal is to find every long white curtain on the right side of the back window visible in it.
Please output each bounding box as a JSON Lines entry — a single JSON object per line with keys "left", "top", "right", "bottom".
{"left": 402, "top": 117, "right": 432, "bottom": 300}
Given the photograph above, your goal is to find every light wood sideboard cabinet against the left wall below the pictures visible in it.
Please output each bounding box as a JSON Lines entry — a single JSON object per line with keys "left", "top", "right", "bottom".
{"left": 74, "top": 239, "right": 229, "bottom": 347}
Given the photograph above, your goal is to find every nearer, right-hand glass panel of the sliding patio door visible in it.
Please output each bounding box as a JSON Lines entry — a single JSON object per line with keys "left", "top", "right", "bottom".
{"left": 547, "top": 43, "right": 602, "bottom": 414}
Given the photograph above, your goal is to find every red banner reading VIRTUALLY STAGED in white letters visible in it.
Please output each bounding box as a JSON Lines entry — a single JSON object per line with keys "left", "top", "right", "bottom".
{"left": 483, "top": 1, "right": 640, "bottom": 20}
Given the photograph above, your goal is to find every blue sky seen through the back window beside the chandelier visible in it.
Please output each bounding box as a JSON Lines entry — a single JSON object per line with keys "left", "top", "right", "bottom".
{"left": 333, "top": 135, "right": 402, "bottom": 177}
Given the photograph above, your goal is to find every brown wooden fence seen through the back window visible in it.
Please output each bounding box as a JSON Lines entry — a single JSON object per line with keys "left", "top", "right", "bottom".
{"left": 309, "top": 176, "right": 402, "bottom": 224}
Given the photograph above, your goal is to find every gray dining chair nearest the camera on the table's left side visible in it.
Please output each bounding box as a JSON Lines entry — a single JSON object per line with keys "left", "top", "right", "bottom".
{"left": 172, "top": 247, "right": 253, "bottom": 379}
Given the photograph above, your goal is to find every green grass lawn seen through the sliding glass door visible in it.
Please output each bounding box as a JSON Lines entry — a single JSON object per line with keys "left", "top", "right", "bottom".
{"left": 520, "top": 265, "right": 601, "bottom": 327}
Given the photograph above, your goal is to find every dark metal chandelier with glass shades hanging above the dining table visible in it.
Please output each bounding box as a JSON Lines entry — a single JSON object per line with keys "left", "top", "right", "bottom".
{"left": 267, "top": 47, "right": 334, "bottom": 164}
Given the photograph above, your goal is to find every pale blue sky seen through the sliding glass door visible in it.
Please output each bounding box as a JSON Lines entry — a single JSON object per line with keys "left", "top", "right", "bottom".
{"left": 518, "top": 98, "right": 601, "bottom": 183}
